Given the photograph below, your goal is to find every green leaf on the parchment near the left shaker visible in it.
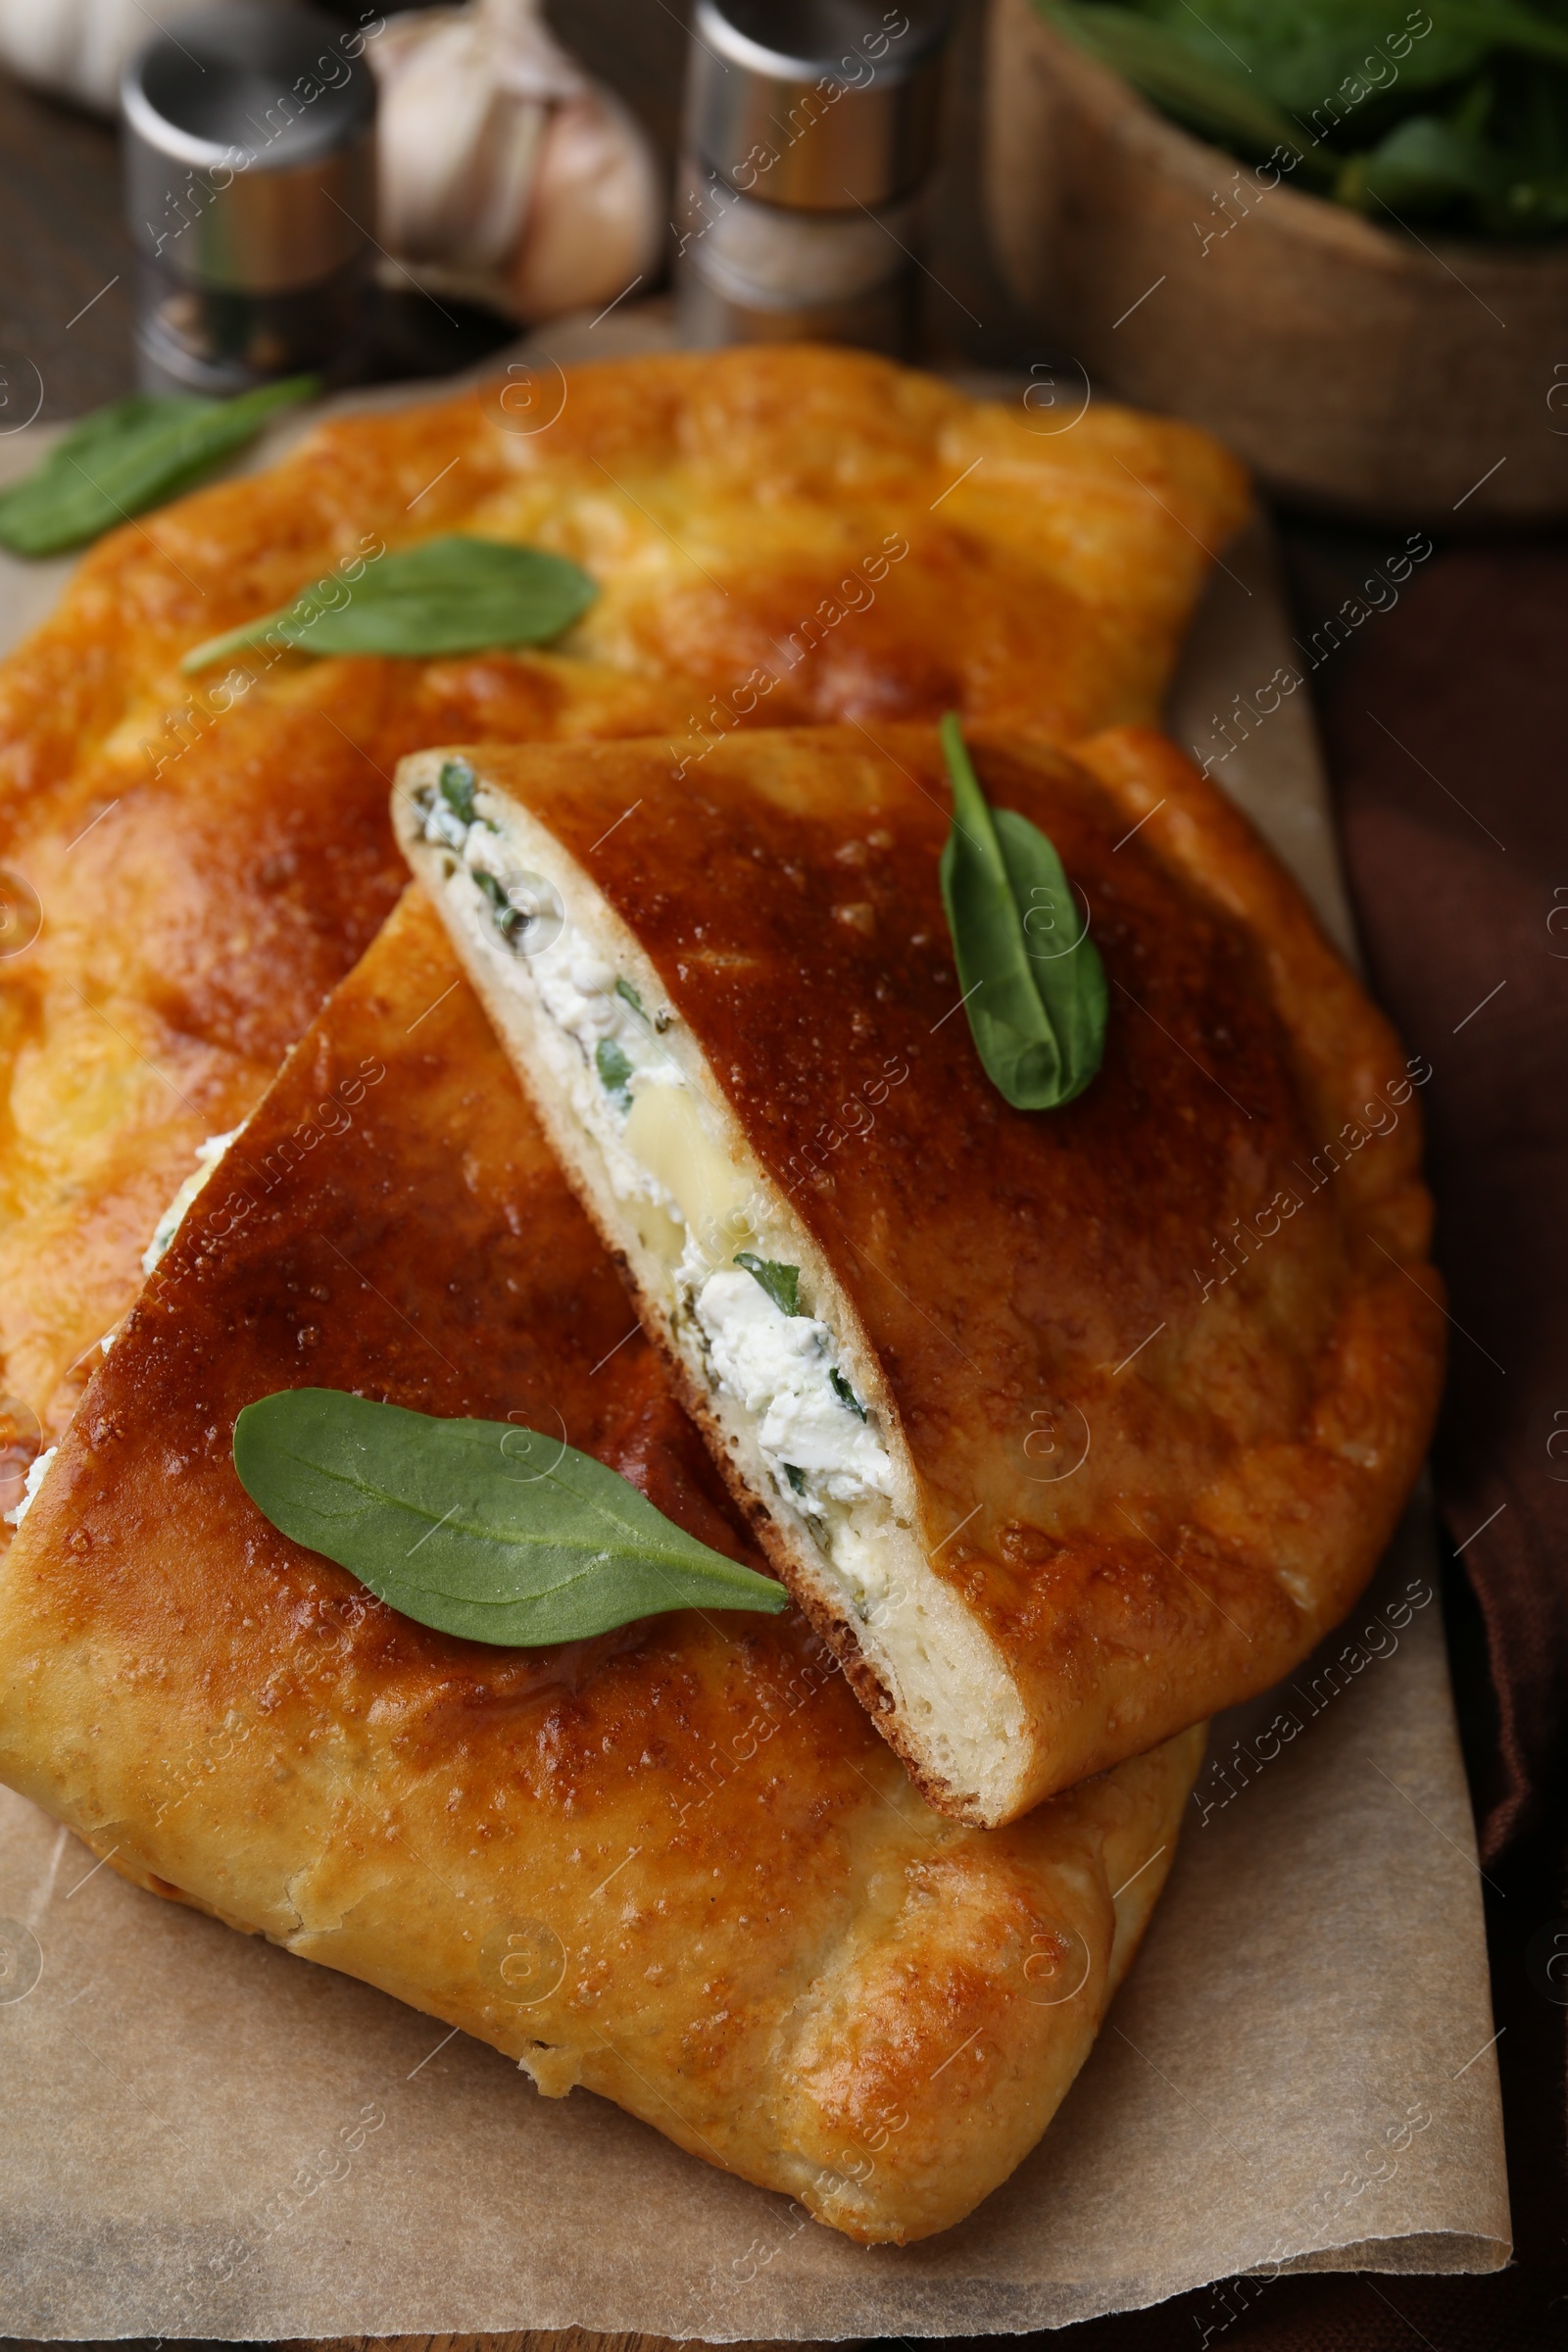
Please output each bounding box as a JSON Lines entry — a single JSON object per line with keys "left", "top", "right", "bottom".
{"left": 0, "top": 376, "right": 319, "bottom": 555}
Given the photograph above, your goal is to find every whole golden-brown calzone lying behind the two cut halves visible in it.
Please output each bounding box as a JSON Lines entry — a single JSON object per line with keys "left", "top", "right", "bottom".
{"left": 0, "top": 346, "right": 1246, "bottom": 1435}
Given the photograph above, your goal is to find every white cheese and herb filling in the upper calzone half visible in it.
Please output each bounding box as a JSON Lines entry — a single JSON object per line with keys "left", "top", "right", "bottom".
{"left": 423, "top": 788, "right": 894, "bottom": 1524}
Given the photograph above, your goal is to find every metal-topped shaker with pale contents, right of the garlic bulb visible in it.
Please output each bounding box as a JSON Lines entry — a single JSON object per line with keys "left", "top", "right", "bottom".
{"left": 672, "top": 0, "right": 950, "bottom": 355}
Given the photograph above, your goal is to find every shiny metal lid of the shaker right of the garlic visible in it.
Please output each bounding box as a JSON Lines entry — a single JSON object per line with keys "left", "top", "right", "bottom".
{"left": 686, "top": 0, "right": 953, "bottom": 212}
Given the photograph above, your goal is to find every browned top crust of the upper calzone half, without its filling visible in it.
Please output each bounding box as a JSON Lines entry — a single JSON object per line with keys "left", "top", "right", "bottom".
{"left": 402, "top": 727, "right": 1444, "bottom": 1821}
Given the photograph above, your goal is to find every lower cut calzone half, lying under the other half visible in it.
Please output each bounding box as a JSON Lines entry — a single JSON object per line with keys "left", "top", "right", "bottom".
{"left": 0, "top": 892, "right": 1201, "bottom": 2241}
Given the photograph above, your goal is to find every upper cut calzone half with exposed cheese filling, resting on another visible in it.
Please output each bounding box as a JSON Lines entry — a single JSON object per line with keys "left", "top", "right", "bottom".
{"left": 395, "top": 727, "right": 1444, "bottom": 1823}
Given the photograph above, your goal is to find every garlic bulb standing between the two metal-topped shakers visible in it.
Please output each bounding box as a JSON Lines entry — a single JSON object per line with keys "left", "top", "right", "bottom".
{"left": 367, "top": 0, "right": 662, "bottom": 324}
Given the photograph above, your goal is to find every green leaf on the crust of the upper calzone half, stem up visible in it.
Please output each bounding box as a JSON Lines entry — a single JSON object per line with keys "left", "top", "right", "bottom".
{"left": 941, "top": 712, "right": 1109, "bottom": 1110}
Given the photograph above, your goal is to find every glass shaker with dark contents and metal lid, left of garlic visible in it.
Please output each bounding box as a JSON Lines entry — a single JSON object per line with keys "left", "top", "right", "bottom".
{"left": 120, "top": 0, "right": 376, "bottom": 393}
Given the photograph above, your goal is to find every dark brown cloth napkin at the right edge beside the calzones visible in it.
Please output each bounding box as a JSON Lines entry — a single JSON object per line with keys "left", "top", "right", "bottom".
{"left": 1326, "top": 551, "right": 1568, "bottom": 1872}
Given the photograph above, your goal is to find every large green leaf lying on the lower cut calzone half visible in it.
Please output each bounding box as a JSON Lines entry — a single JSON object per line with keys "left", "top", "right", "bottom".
{"left": 235, "top": 1388, "right": 788, "bottom": 1648}
